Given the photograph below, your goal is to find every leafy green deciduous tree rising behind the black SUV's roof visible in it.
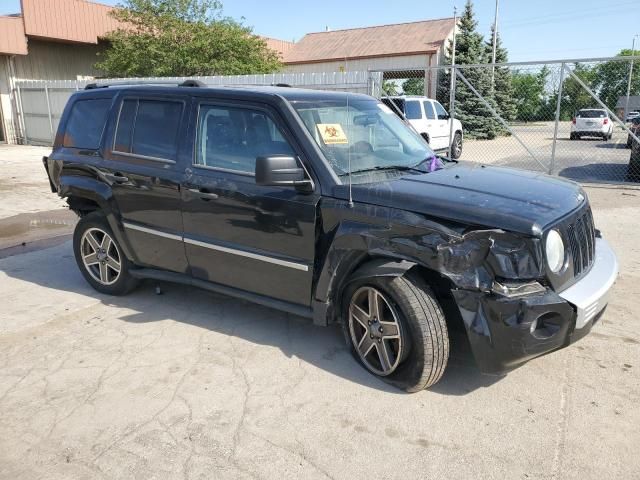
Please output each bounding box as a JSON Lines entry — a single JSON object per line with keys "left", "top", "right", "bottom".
{"left": 96, "top": 0, "right": 281, "bottom": 77}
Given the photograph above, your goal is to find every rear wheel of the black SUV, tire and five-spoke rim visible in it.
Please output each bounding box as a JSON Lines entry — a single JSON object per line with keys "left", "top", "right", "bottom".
{"left": 73, "top": 212, "right": 137, "bottom": 295}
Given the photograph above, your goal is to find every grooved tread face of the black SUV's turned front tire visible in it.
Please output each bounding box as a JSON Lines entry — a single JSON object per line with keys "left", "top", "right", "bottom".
{"left": 393, "top": 273, "right": 449, "bottom": 392}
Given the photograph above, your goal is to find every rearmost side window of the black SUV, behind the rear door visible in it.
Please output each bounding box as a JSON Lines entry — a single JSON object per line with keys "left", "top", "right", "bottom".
{"left": 62, "top": 98, "right": 111, "bottom": 150}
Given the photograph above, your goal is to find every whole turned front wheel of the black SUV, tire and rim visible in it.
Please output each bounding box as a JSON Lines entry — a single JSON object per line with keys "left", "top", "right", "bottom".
{"left": 342, "top": 273, "right": 449, "bottom": 392}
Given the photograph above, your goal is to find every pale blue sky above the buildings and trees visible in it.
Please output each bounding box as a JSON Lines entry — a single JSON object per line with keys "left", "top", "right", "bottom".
{"left": 0, "top": 0, "right": 640, "bottom": 61}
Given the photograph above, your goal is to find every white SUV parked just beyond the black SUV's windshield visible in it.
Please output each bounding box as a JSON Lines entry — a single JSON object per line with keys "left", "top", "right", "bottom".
{"left": 382, "top": 95, "right": 462, "bottom": 159}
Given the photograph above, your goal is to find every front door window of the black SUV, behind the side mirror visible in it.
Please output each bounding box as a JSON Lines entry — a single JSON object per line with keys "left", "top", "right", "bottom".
{"left": 195, "top": 105, "right": 294, "bottom": 173}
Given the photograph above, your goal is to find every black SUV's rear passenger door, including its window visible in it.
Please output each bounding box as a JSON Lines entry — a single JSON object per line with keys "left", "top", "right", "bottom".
{"left": 104, "top": 95, "right": 190, "bottom": 273}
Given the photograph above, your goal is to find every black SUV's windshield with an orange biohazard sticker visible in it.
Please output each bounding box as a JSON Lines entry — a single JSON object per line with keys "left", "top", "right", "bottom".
{"left": 292, "top": 97, "right": 435, "bottom": 183}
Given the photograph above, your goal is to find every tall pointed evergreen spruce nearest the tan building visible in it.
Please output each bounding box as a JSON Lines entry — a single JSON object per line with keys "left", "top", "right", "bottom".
{"left": 437, "top": 0, "right": 498, "bottom": 139}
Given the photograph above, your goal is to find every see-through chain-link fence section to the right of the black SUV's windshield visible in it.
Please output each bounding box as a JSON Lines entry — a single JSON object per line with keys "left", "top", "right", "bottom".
{"left": 371, "top": 57, "right": 640, "bottom": 183}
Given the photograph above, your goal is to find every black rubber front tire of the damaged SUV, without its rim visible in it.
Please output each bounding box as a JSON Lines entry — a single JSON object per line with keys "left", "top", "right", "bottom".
{"left": 342, "top": 272, "right": 449, "bottom": 393}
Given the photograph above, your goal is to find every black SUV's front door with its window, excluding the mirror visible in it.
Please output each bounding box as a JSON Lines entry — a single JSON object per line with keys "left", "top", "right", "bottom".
{"left": 182, "top": 103, "right": 319, "bottom": 305}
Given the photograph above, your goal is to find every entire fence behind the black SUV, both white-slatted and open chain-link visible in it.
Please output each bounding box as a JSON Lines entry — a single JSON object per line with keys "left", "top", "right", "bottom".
{"left": 16, "top": 57, "right": 640, "bottom": 183}
